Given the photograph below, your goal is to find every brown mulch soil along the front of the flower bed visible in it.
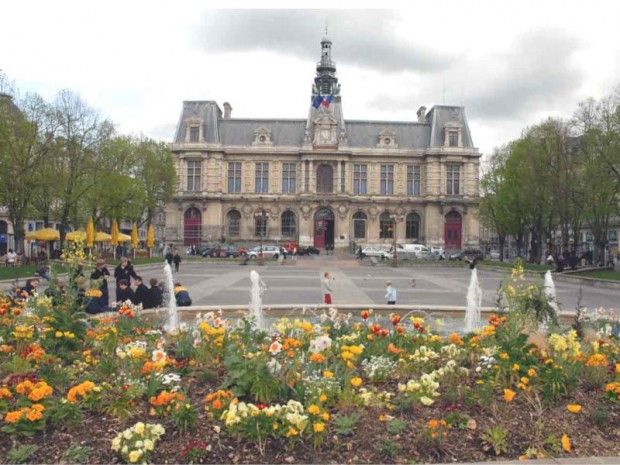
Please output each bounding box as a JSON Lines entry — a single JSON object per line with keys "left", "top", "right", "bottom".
{"left": 0, "top": 378, "right": 620, "bottom": 464}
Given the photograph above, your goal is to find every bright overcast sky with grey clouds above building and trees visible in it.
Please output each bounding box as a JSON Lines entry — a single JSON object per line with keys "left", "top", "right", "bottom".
{"left": 0, "top": 0, "right": 620, "bottom": 155}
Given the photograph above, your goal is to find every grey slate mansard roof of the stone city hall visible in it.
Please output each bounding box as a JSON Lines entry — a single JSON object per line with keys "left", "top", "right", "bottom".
{"left": 174, "top": 100, "right": 474, "bottom": 149}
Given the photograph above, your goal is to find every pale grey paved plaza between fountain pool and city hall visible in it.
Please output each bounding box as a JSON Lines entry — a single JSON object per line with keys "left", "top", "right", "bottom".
{"left": 120, "top": 256, "right": 620, "bottom": 311}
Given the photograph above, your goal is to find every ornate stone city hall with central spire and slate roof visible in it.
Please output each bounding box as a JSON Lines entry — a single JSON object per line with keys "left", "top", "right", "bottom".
{"left": 165, "top": 38, "right": 481, "bottom": 249}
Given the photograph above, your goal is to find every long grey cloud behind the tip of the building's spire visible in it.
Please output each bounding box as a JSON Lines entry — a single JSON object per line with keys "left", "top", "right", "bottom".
{"left": 193, "top": 10, "right": 454, "bottom": 72}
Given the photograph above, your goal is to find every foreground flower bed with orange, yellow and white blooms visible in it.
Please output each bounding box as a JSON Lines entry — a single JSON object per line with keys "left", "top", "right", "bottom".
{"left": 0, "top": 258, "right": 620, "bottom": 463}
